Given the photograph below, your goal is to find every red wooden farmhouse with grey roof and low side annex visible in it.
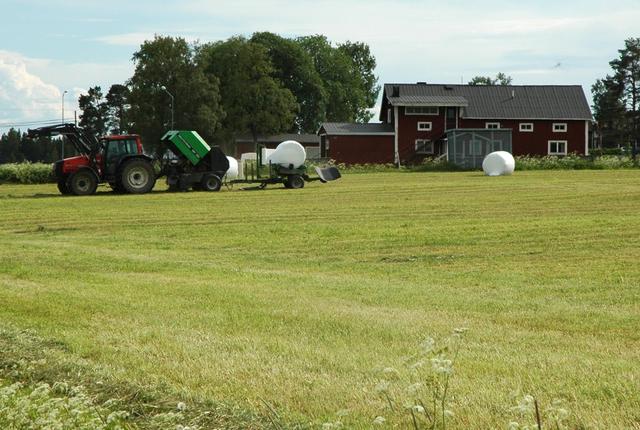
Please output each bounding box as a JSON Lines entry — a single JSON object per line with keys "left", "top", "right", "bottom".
{"left": 318, "top": 82, "right": 593, "bottom": 166}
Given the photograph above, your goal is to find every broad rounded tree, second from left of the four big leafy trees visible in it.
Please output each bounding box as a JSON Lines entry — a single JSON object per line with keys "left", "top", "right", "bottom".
{"left": 198, "top": 37, "right": 298, "bottom": 150}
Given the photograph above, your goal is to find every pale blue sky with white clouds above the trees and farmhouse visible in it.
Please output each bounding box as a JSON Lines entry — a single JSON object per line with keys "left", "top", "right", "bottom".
{"left": 0, "top": 0, "right": 640, "bottom": 133}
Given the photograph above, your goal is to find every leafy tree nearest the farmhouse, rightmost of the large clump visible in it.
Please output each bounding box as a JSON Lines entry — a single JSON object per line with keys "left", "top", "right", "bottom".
{"left": 296, "top": 35, "right": 379, "bottom": 122}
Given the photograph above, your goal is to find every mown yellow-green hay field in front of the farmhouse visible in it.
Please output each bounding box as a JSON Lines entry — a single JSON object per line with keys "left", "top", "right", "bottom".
{"left": 0, "top": 170, "right": 640, "bottom": 429}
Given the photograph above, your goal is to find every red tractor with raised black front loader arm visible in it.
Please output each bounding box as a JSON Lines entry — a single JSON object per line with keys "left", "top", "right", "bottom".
{"left": 28, "top": 124, "right": 156, "bottom": 196}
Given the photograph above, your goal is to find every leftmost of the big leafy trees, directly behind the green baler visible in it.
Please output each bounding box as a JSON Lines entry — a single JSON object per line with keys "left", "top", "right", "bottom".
{"left": 127, "top": 36, "right": 224, "bottom": 154}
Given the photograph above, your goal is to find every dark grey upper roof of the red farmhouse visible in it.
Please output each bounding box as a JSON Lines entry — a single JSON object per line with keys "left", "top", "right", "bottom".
{"left": 384, "top": 84, "right": 593, "bottom": 120}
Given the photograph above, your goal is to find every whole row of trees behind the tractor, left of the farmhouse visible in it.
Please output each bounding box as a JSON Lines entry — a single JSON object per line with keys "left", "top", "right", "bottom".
{"left": 79, "top": 32, "right": 380, "bottom": 155}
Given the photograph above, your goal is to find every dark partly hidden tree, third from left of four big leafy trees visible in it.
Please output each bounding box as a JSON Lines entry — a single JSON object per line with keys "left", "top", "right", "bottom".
{"left": 250, "top": 32, "right": 326, "bottom": 133}
